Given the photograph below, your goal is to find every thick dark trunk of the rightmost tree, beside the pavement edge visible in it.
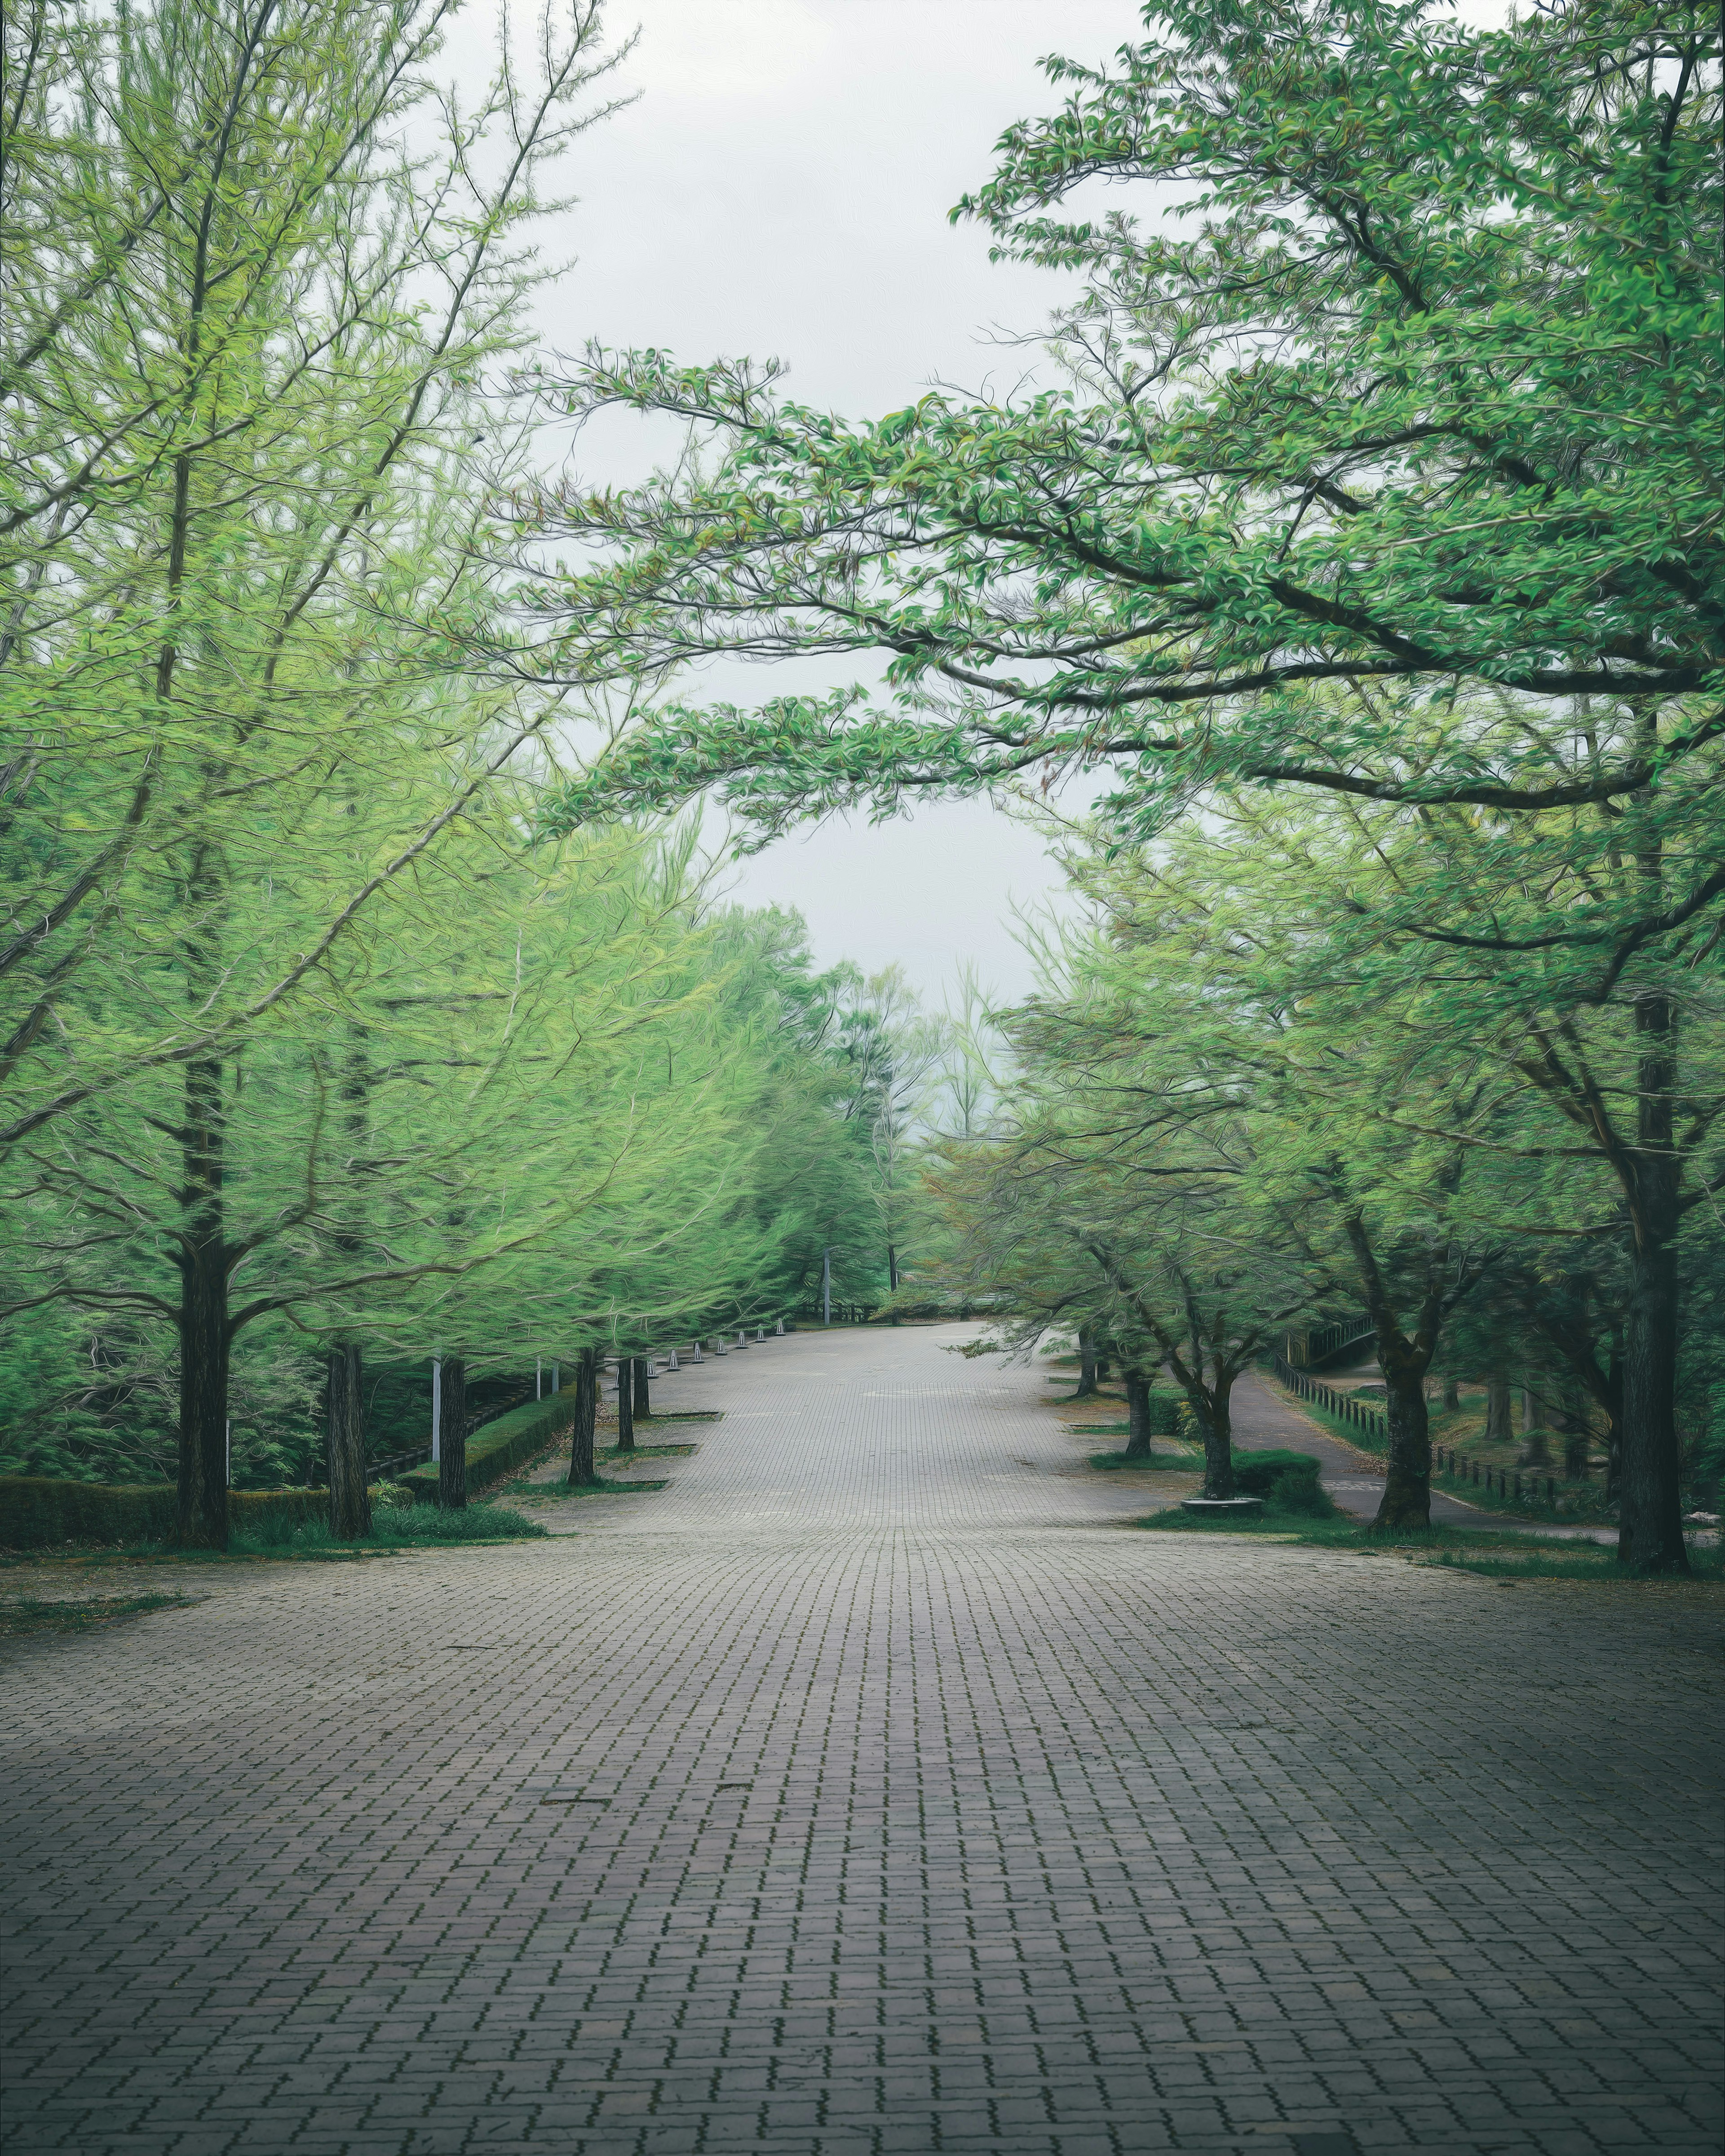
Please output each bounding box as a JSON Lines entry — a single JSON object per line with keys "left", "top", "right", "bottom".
{"left": 1617, "top": 994, "right": 1688, "bottom": 1572}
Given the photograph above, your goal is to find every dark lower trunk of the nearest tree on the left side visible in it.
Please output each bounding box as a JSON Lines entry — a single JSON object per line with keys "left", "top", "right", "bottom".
{"left": 175, "top": 1059, "right": 231, "bottom": 1550}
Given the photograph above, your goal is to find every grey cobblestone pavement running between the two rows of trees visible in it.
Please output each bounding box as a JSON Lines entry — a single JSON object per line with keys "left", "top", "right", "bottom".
{"left": 6, "top": 1330, "right": 1721, "bottom": 2156}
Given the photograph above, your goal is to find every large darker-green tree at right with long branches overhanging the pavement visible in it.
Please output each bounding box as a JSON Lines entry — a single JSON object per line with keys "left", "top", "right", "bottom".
{"left": 519, "top": 0, "right": 1725, "bottom": 1568}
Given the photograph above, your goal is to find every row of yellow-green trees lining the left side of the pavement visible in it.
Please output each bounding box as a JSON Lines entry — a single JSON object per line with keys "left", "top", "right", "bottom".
{"left": 0, "top": 0, "right": 888, "bottom": 1544}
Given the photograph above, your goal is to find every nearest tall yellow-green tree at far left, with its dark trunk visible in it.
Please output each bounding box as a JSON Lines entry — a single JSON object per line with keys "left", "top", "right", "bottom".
{"left": 0, "top": 0, "right": 625, "bottom": 1542}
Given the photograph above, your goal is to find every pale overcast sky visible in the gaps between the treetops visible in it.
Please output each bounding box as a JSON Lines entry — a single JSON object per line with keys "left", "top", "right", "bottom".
{"left": 478, "top": 0, "right": 1138, "bottom": 1005}
